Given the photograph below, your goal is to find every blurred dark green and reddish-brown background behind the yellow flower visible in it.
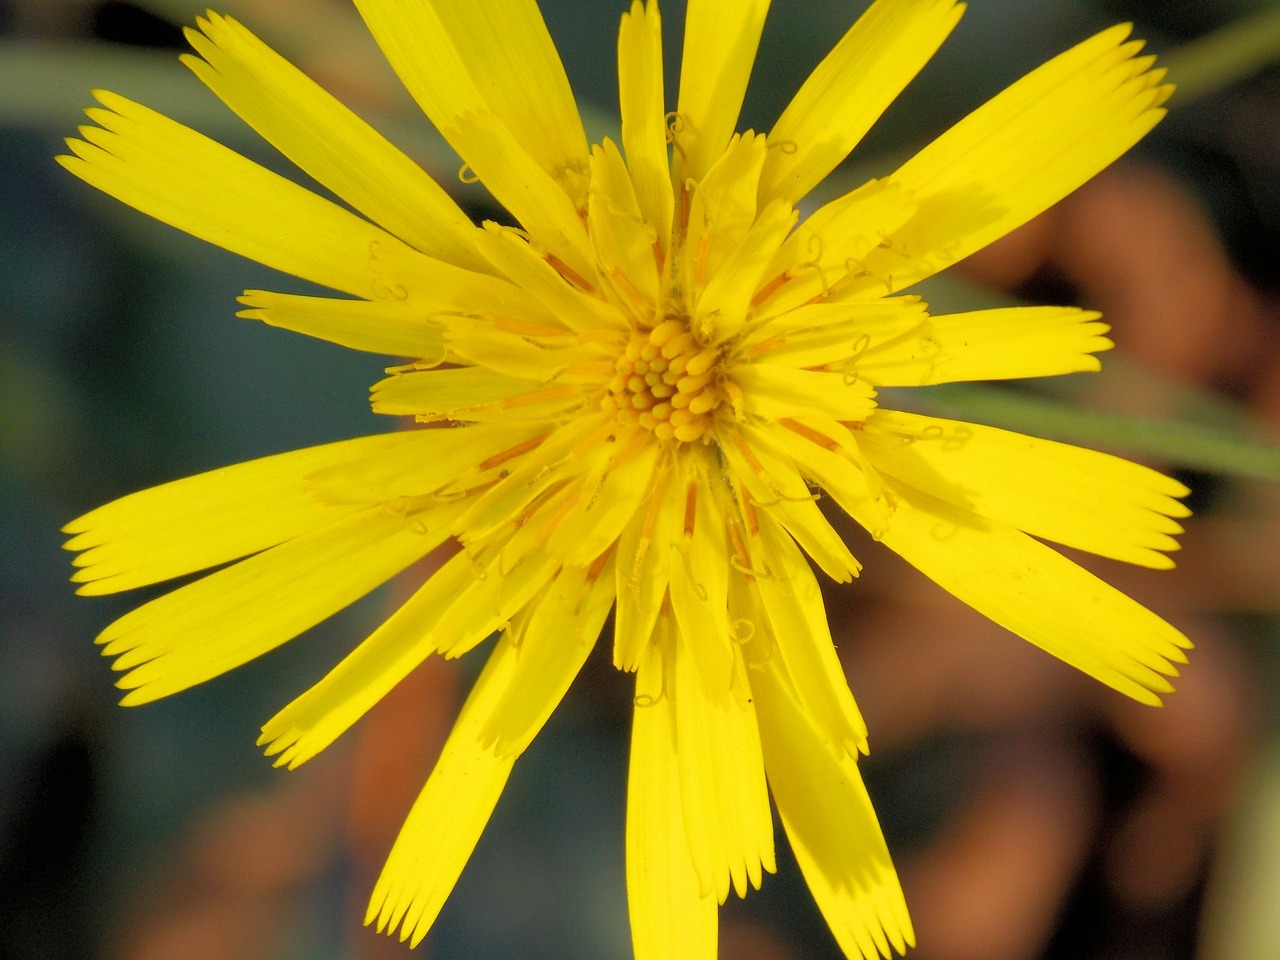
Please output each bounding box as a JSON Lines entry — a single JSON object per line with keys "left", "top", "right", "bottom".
{"left": 0, "top": 0, "right": 1280, "bottom": 960}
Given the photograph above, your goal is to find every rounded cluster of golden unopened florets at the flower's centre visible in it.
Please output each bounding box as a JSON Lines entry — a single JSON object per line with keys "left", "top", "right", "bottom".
{"left": 600, "top": 319, "right": 721, "bottom": 443}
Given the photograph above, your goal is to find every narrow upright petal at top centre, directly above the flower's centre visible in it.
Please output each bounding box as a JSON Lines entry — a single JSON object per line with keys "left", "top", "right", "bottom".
{"left": 618, "top": 0, "right": 673, "bottom": 247}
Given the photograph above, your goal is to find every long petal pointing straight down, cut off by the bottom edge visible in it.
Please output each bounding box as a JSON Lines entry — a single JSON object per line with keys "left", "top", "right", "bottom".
{"left": 626, "top": 632, "right": 717, "bottom": 960}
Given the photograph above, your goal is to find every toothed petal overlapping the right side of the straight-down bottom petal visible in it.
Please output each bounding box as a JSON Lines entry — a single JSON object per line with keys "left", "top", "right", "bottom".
{"left": 667, "top": 634, "right": 776, "bottom": 904}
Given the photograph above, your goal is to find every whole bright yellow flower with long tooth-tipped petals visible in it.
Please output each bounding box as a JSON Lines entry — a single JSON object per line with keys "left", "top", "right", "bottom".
{"left": 60, "top": 0, "right": 1189, "bottom": 960}
